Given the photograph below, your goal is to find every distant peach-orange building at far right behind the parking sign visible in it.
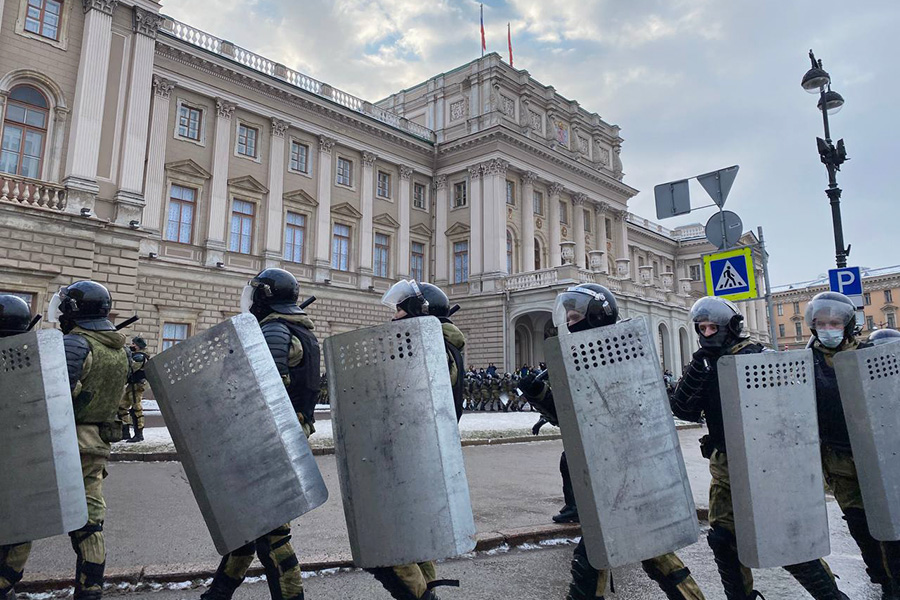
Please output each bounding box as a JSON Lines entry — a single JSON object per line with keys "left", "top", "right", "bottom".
{"left": 772, "top": 265, "right": 900, "bottom": 350}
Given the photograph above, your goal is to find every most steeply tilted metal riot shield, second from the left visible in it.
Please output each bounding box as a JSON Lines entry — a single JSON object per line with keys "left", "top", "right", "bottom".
{"left": 146, "top": 314, "right": 328, "bottom": 555}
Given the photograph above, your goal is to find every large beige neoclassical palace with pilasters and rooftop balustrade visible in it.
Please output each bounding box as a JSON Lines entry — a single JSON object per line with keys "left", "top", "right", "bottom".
{"left": 0, "top": 0, "right": 768, "bottom": 371}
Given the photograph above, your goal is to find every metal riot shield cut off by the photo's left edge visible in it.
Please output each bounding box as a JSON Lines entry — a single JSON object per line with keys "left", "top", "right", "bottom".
{"left": 0, "top": 329, "right": 87, "bottom": 545}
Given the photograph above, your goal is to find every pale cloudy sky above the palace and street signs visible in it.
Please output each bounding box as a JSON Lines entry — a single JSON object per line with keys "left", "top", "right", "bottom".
{"left": 163, "top": 0, "right": 900, "bottom": 285}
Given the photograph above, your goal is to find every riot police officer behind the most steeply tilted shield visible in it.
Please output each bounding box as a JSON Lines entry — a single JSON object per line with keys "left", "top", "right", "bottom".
{"left": 201, "top": 269, "right": 321, "bottom": 600}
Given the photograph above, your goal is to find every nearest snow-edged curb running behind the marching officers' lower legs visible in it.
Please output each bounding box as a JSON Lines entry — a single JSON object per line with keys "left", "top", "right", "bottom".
{"left": 16, "top": 508, "right": 709, "bottom": 594}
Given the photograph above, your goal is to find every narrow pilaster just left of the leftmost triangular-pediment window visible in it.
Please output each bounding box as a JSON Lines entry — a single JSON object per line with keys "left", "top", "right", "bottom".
{"left": 142, "top": 77, "right": 175, "bottom": 233}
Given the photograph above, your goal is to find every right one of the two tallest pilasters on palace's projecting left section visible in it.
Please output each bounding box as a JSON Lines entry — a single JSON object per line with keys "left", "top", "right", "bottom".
{"left": 116, "top": 6, "right": 163, "bottom": 225}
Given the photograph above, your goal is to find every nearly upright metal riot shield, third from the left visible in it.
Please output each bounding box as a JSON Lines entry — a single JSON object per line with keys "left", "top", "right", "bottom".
{"left": 325, "top": 317, "right": 475, "bottom": 568}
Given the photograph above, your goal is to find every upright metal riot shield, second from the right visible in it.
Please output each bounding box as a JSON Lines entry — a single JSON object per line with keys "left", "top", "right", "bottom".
{"left": 717, "top": 350, "right": 831, "bottom": 569}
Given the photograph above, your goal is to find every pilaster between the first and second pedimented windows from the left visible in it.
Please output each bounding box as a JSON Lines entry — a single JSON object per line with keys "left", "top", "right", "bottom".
{"left": 206, "top": 98, "right": 237, "bottom": 267}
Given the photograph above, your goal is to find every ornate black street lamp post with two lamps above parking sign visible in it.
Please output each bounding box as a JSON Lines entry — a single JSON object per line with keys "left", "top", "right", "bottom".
{"left": 800, "top": 50, "right": 850, "bottom": 268}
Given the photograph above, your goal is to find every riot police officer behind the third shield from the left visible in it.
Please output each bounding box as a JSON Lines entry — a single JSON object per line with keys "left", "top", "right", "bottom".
{"left": 374, "top": 280, "right": 466, "bottom": 600}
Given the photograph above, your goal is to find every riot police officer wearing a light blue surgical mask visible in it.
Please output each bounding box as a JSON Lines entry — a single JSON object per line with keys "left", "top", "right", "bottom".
{"left": 805, "top": 292, "right": 900, "bottom": 600}
